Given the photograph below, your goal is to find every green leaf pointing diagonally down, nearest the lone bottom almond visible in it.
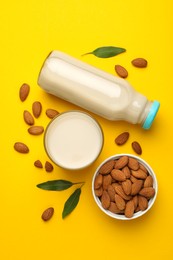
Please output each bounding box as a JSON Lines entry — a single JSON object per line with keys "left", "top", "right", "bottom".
{"left": 62, "top": 188, "right": 81, "bottom": 218}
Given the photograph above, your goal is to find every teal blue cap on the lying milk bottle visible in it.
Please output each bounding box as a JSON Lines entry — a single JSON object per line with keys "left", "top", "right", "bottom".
{"left": 142, "top": 101, "right": 160, "bottom": 129}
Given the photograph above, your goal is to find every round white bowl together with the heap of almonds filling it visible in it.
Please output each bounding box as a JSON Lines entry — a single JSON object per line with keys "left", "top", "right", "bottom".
{"left": 92, "top": 154, "right": 158, "bottom": 220}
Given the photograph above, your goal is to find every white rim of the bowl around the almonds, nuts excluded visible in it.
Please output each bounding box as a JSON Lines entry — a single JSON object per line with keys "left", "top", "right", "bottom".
{"left": 92, "top": 154, "right": 158, "bottom": 220}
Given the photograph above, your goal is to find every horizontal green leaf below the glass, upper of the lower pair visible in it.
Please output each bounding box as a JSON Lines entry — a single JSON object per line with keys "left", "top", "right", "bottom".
{"left": 37, "top": 180, "right": 73, "bottom": 191}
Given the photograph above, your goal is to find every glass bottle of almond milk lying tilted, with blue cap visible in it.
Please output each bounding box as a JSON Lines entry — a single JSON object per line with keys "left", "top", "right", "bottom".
{"left": 38, "top": 51, "right": 160, "bottom": 129}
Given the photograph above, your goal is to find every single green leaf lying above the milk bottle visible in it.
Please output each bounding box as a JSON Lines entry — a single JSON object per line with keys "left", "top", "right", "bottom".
{"left": 84, "top": 46, "right": 126, "bottom": 58}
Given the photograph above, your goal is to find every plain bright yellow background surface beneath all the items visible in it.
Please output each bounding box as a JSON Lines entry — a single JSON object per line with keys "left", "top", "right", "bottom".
{"left": 0, "top": 0, "right": 173, "bottom": 260}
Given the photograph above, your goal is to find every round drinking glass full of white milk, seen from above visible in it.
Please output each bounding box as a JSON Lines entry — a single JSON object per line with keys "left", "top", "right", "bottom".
{"left": 44, "top": 110, "right": 104, "bottom": 170}
